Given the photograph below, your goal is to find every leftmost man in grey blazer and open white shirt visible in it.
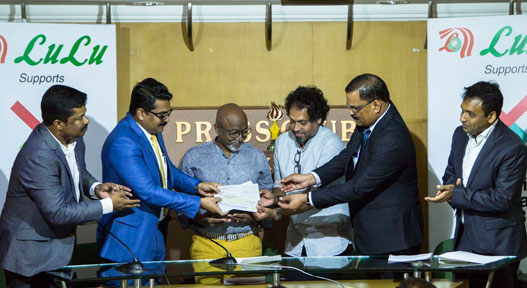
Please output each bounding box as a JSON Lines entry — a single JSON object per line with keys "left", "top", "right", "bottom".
{"left": 0, "top": 85, "right": 139, "bottom": 287}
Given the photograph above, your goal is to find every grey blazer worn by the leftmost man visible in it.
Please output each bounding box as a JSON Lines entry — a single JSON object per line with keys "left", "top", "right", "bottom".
{"left": 0, "top": 124, "right": 102, "bottom": 277}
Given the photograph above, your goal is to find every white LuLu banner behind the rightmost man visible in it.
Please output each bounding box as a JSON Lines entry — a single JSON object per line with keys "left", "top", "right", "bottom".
{"left": 428, "top": 16, "right": 527, "bottom": 270}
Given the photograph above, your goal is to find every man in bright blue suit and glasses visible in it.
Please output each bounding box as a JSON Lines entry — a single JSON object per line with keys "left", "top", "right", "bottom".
{"left": 97, "top": 78, "right": 222, "bottom": 274}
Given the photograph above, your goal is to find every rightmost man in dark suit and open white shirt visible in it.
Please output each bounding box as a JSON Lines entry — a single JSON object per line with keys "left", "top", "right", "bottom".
{"left": 425, "top": 82, "right": 527, "bottom": 287}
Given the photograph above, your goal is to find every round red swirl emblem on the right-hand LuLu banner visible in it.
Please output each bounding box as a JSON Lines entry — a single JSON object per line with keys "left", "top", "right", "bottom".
{"left": 439, "top": 28, "right": 474, "bottom": 58}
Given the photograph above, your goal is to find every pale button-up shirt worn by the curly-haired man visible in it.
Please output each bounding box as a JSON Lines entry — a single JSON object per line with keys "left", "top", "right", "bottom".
{"left": 273, "top": 126, "right": 351, "bottom": 257}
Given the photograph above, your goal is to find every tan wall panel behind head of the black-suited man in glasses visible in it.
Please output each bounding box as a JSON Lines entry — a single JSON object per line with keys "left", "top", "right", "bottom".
{"left": 313, "top": 22, "right": 427, "bottom": 119}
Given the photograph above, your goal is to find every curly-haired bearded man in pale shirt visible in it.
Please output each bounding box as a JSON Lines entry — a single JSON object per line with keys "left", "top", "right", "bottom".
{"left": 258, "top": 86, "right": 353, "bottom": 280}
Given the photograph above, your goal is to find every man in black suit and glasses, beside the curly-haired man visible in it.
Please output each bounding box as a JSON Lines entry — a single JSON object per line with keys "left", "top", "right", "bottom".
{"left": 274, "top": 74, "right": 423, "bottom": 255}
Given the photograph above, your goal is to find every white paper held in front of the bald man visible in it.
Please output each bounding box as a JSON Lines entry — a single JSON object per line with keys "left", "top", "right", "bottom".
{"left": 214, "top": 181, "right": 260, "bottom": 212}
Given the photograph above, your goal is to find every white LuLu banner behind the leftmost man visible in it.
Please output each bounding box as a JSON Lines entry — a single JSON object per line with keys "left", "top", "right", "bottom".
{"left": 0, "top": 23, "right": 117, "bottom": 210}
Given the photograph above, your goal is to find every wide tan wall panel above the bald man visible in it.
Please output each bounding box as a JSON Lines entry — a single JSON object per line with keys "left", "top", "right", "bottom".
{"left": 117, "top": 23, "right": 313, "bottom": 117}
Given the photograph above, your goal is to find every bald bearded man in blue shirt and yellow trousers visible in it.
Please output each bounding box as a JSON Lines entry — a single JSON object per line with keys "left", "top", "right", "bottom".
{"left": 180, "top": 103, "right": 273, "bottom": 284}
